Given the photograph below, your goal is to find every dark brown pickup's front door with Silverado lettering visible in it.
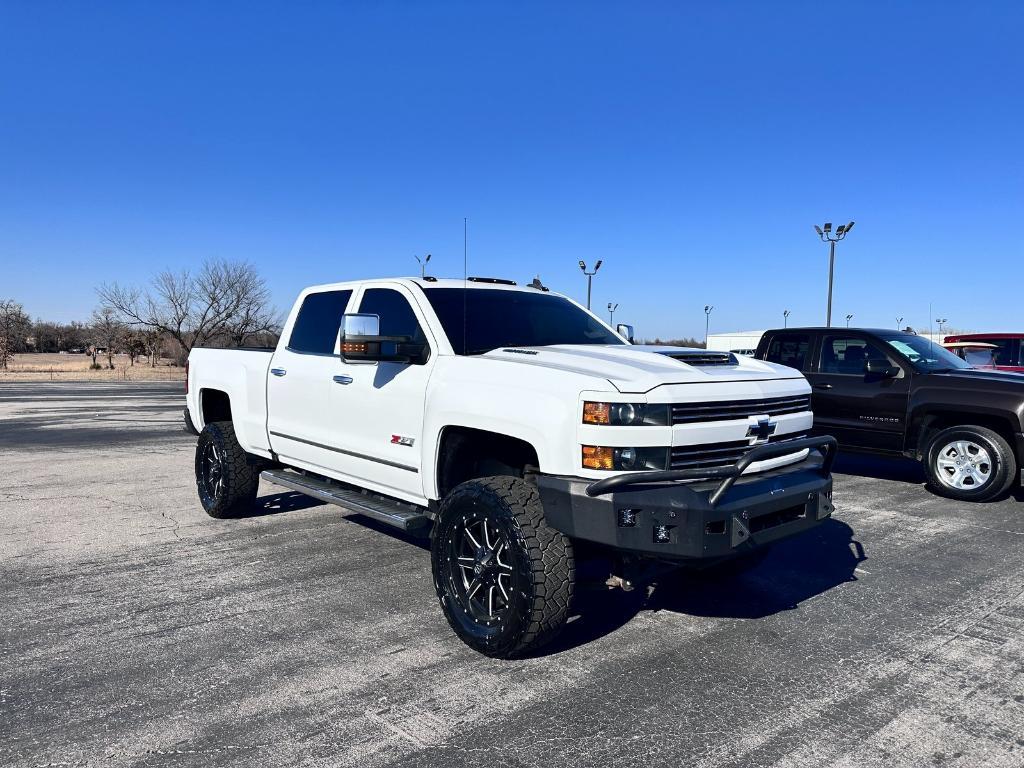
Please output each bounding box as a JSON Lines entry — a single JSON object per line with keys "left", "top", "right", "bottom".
{"left": 806, "top": 331, "right": 912, "bottom": 452}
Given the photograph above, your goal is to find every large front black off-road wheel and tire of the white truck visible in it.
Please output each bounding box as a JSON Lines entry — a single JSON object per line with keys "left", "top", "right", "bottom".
{"left": 430, "top": 477, "right": 575, "bottom": 658}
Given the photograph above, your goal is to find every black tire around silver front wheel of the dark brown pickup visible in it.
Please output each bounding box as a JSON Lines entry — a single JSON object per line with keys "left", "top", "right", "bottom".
{"left": 923, "top": 424, "right": 1017, "bottom": 502}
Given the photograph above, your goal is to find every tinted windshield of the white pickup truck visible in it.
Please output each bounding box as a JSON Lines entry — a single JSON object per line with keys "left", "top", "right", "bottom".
{"left": 424, "top": 288, "right": 623, "bottom": 354}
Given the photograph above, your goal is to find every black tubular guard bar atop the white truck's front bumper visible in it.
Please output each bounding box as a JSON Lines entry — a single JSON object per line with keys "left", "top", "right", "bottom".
{"left": 587, "top": 435, "right": 838, "bottom": 507}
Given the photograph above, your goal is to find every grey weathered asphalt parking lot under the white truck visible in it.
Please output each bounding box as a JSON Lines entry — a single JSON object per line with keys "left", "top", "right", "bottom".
{"left": 0, "top": 384, "right": 1024, "bottom": 768}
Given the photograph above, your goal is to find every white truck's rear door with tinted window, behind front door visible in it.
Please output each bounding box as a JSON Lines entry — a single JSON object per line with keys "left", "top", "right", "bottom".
{"left": 266, "top": 289, "right": 352, "bottom": 470}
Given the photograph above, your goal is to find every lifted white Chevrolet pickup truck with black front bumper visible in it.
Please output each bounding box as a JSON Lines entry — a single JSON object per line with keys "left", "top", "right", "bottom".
{"left": 185, "top": 278, "right": 835, "bottom": 657}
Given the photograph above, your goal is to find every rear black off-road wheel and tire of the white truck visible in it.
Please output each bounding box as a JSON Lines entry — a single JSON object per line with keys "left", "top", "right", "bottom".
{"left": 196, "top": 421, "right": 262, "bottom": 518}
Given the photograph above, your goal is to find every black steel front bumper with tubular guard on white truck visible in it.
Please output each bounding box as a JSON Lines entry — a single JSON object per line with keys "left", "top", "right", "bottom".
{"left": 538, "top": 436, "right": 837, "bottom": 560}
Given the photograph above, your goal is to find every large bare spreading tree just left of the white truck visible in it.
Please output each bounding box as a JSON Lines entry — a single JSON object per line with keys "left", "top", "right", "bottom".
{"left": 97, "top": 260, "right": 275, "bottom": 361}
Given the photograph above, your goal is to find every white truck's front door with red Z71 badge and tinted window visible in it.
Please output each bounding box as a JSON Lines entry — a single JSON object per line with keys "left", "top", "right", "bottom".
{"left": 327, "top": 284, "right": 437, "bottom": 503}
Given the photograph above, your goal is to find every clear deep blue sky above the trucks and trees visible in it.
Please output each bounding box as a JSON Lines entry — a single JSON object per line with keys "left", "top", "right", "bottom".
{"left": 0, "top": 0, "right": 1024, "bottom": 337}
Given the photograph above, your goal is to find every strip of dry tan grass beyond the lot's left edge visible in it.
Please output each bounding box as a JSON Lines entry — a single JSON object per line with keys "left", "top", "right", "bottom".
{"left": 0, "top": 352, "right": 185, "bottom": 383}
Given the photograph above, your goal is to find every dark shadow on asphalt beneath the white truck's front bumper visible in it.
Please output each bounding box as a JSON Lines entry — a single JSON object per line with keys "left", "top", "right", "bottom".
{"left": 539, "top": 519, "right": 867, "bottom": 655}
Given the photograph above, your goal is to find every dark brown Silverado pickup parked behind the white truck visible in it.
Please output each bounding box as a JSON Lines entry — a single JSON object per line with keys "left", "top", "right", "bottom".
{"left": 756, "top": 328, "right": 1024, "bottom": 502}
